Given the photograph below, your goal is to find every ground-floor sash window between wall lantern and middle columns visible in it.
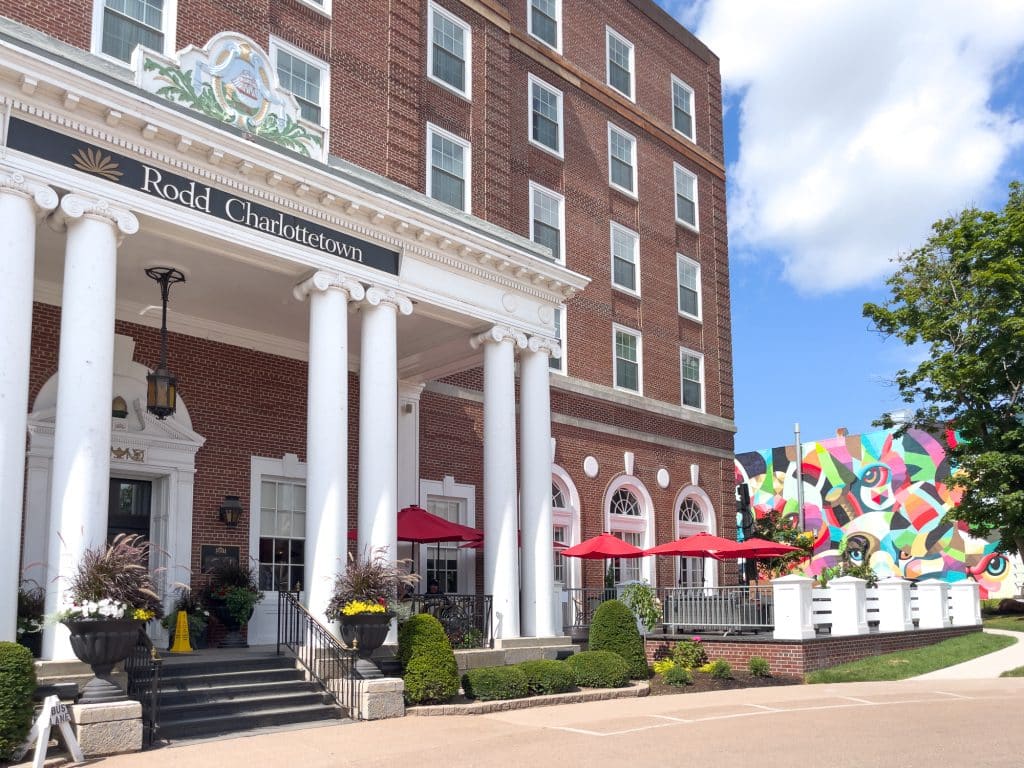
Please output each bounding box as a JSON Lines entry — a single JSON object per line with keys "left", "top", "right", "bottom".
{"left": 259, "top": 480, "right": 306, "bottom": 591}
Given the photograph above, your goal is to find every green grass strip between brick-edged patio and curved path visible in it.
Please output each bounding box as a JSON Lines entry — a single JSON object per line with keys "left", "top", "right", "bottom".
{"left": 806, "top": 632, "right": 1017, "bottom": 683}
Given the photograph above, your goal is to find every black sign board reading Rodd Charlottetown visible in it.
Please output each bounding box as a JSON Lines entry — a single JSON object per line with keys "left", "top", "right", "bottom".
{"left": 7, "top": 118, "right": 399, "bottom": 274}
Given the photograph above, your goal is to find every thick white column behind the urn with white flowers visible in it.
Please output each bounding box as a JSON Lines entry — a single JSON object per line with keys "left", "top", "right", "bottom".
{"left": 43, "top": 195, "right": 138, "bottom": 659}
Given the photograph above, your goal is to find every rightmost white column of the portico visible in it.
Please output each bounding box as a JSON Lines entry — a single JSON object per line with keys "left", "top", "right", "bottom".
{"left": 519, "top": 336, "right": 562, "bottom": 637}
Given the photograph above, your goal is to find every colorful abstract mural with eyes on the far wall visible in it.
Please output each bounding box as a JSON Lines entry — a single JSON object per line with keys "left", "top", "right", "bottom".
{"left": 735, "top": 429, "right": 1024, "bottom": 598}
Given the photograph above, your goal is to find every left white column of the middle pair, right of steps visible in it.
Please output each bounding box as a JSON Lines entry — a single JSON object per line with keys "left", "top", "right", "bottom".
{"left": 294, "top": 271, "right": 364, "bottom": 628}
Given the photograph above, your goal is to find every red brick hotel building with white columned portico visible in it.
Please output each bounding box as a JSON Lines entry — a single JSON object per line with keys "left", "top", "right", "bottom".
{"left": 0, "top": 0, "right": 734, "bottom": 657}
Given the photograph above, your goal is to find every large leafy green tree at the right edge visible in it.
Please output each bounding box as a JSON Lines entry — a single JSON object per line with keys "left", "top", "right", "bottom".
{"left": 863, "top": 181, "right": 1024, "bottom": 554}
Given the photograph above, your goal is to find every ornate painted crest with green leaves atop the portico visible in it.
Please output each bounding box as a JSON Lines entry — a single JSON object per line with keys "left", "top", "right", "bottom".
{"left": 132, "top": 32, "right": 326, "bottom": 160}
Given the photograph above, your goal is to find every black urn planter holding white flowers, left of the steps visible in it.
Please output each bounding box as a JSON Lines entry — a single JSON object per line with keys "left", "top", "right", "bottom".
{"left": 65, "top": 618, "right": 142, "bottom": 703}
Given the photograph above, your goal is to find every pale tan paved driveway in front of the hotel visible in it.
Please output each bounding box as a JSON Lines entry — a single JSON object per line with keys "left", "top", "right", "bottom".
{"left": 98, "top": 678, "right": 1024, "bottom": 768}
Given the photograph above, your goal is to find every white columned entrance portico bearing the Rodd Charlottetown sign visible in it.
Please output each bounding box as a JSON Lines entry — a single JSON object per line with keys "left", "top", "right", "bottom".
{"left": 0, "top": 27, "right": 587, "bottom": 658}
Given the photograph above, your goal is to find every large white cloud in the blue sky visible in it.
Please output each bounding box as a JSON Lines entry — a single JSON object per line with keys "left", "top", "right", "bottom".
{"left": 692, "top": 0, "right": 1024, "bottom": 293}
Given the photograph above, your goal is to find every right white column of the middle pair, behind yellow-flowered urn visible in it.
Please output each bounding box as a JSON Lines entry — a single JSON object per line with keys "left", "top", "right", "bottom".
{"left": 357, "top": 286, "right": 413, "bottom": 560}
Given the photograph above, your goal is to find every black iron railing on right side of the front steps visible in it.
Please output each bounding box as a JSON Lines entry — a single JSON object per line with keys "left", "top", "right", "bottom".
{"left": 278, "top": 592, "right": 359, "bottom": 720}
